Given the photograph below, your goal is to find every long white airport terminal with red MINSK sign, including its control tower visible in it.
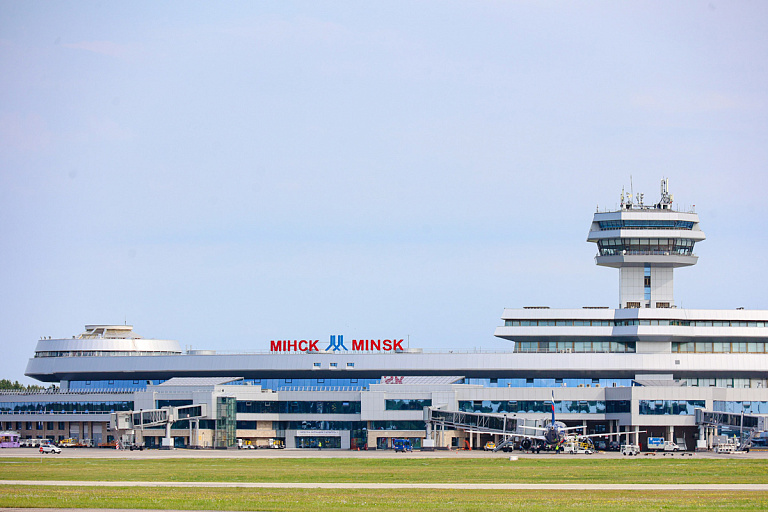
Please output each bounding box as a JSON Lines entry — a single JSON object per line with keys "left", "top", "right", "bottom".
{"left": 0, "top": 181, "right": 768, "bottom": 449}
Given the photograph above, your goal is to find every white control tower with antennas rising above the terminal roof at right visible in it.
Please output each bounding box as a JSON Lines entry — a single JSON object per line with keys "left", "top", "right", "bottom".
{"left": 587, "top": 179, "right": 705, "bottom": 309}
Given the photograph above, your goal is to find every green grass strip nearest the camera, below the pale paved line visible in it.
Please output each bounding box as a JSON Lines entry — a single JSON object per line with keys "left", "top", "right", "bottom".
{"left": 0, "top": 486, "right": 768, "bottom": 512}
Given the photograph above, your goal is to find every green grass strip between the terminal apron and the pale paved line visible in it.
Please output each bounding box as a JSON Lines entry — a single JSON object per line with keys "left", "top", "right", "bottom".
{"left": 0, "top": 456, "right": 768, "bottom": 484}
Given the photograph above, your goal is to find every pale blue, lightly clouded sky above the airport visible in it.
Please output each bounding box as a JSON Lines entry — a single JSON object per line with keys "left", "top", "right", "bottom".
{"left": 0, "top": 0, "right": 768, "bottom": 383}
